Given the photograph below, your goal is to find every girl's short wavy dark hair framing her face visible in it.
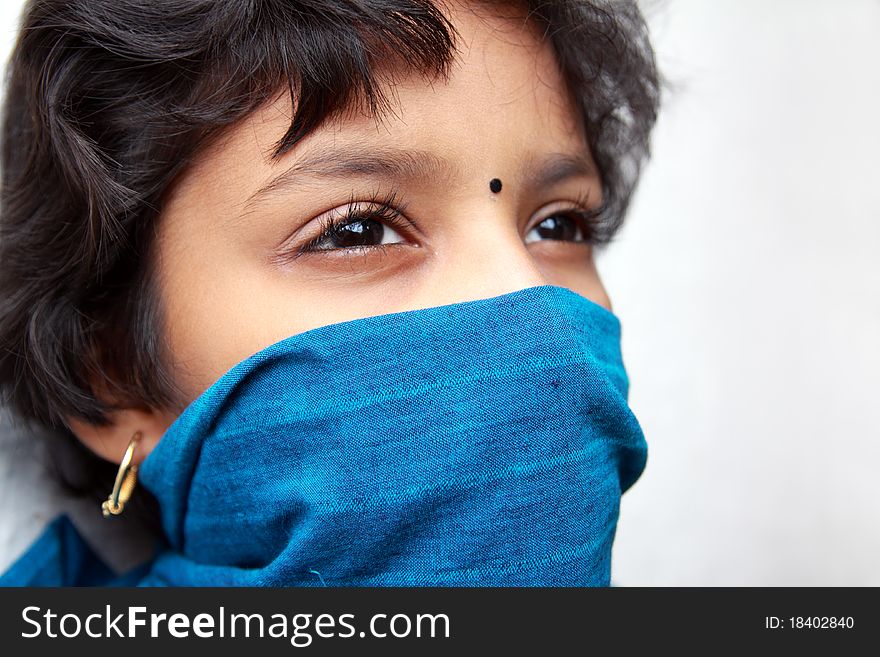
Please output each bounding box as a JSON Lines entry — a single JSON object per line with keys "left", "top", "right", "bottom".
{"left": 0, "top": 0, "right": 659, "bottom": 502}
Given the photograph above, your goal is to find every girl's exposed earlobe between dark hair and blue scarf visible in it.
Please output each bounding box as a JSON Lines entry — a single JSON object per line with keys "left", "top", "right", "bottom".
{"left": 67, "top": 408, "right": 177, "bottom": 465}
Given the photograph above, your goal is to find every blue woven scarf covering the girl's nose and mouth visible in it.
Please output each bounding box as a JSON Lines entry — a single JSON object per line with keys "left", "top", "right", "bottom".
{"left": 0, "top": 285, "right": 647, "bottom": 586}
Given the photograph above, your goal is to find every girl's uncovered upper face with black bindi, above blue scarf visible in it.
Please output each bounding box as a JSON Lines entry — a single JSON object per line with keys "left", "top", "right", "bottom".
{"left": 74, "top": 1, "right": 611, "bottom": 460}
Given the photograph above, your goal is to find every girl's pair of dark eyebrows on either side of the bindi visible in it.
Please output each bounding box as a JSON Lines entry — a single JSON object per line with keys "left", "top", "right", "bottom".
{"left": 244, "top": 147, "right": 598, "bottom": 212}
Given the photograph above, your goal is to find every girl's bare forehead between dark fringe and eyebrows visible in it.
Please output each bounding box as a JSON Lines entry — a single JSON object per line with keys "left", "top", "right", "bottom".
{"left": 173, "top": 3, "right": 589, "bottom": 197}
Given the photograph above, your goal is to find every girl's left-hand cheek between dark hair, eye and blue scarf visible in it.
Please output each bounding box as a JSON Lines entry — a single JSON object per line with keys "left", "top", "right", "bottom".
{"left": 158, "top": 235, "right": 412, "bottom": 402}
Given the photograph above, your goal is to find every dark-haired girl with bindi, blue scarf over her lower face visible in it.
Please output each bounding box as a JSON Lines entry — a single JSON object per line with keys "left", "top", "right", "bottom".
{"left": 0, "top": 0, "right": 658, "bottom": 586}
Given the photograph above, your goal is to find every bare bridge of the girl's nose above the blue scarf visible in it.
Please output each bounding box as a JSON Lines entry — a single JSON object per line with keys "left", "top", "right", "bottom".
{"left": 420, "top": 214, "right": 550, "bottom": 304}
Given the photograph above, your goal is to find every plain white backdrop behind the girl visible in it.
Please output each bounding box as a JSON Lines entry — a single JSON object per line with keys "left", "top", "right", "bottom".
{"left": 0, "top": 0, "right": 880, "bottom": 586}
